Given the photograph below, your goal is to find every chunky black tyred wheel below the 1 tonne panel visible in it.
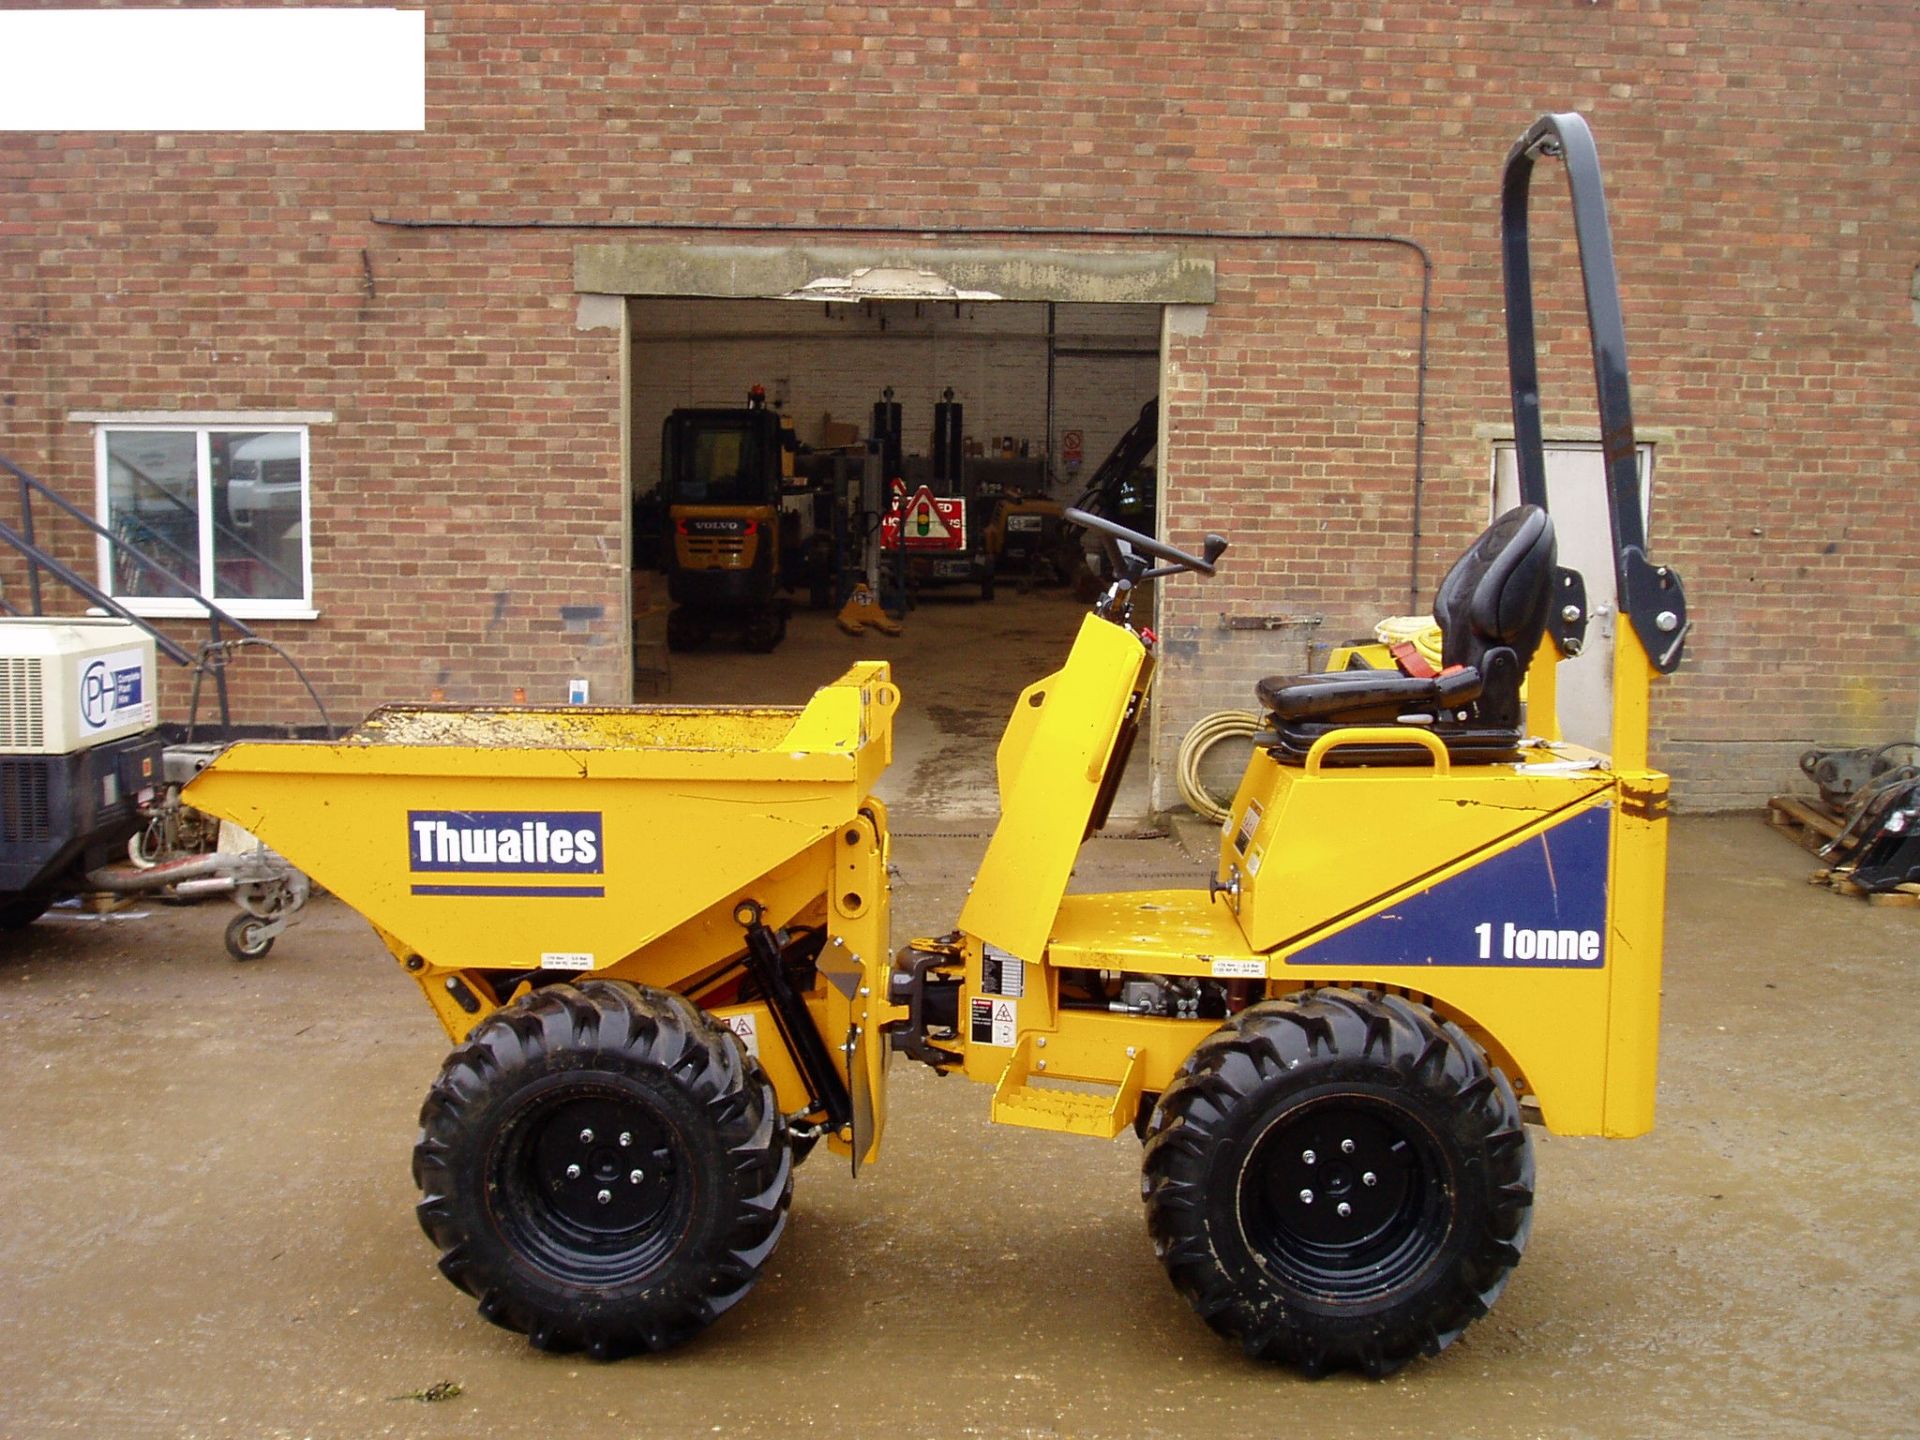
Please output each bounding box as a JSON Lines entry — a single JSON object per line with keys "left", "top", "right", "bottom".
{"left": 1142, "top": 989, "right": 1534, "bottom": 1377}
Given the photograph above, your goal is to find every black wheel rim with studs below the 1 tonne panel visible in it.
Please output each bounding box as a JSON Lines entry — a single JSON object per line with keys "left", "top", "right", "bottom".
{"left": 1238, "top": 1094, "right": 1452, "bottom": 1300}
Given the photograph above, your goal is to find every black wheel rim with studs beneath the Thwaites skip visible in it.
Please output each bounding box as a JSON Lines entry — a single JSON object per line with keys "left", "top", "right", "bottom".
{"left": 490, "top": 1085, "right": 691, "bottom": 1284}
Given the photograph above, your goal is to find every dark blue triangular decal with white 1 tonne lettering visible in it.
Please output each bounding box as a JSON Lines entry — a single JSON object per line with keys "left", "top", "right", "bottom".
{"left": 1286, "top": 806, "right": 1613, "bottom": 970}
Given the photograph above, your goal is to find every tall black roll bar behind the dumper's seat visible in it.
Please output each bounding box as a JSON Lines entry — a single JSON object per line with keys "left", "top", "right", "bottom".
{"left": 1500, "top": 111, "right": 1688, "bottom": 674}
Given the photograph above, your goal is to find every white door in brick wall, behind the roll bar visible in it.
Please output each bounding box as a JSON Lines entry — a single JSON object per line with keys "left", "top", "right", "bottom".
{"left": 1494, "top": 440, "right": 1653, "bottom": 753}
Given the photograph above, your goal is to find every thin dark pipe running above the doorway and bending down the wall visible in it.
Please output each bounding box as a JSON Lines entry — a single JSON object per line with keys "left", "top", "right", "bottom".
{"left": 372, "top": 215, "right": 1434, "bottom": 611}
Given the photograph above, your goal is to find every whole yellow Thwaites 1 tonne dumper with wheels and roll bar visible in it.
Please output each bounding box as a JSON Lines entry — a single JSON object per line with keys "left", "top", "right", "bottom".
{"left": 188, "top": 115, "right": 1686, "bottom": 1375}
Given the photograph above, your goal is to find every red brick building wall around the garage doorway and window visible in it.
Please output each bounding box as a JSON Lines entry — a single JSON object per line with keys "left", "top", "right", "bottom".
{"left": 0, "top": 0, "right": 1920, "bottom": 804}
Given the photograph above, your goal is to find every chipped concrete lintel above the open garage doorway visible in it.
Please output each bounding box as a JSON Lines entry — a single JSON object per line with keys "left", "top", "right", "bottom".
{"left": 574, "top": 240, "right": 1213, "bottom": 305}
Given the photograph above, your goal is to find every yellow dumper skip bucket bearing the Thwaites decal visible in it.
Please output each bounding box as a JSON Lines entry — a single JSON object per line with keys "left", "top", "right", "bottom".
{"left": 184, "top": 662, "right": 899, "bottom": 970}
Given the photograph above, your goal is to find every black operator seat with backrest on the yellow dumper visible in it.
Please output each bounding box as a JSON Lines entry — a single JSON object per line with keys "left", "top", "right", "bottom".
{"left": 1254, "top": 505, "right": 1557, "bottom": 764}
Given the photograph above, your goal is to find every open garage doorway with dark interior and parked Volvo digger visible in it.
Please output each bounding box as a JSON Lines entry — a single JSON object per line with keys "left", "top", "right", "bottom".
{"left": 628, "top": 296, "right": 1162, "bottom": 822}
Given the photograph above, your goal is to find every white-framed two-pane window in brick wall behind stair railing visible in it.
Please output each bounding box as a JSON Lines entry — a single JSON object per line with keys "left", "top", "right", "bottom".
{"left": 94, "top": 417, "right": 315, "bottom": 620}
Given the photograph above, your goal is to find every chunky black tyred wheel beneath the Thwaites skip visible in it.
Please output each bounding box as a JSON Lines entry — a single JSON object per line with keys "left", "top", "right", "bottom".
{"left": 413, "top": 981, "right": 793, "bottom": 1359}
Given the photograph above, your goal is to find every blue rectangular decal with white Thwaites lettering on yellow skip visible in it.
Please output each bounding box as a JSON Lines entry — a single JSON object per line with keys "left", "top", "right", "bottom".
{"left": 407, "top": 810, "right": 607, "bottom": 899}
